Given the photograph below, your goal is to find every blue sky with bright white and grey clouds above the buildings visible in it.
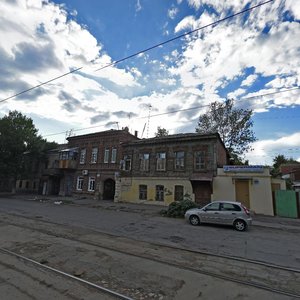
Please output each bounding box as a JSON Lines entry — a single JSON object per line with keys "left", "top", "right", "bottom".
{"left": 0, "top": 0, "right": 300, "bottom": 165}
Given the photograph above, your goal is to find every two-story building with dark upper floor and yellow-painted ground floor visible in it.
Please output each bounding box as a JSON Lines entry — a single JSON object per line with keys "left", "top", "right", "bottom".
{"left": 115, "top": 133, "right": 229, "bottom": 205}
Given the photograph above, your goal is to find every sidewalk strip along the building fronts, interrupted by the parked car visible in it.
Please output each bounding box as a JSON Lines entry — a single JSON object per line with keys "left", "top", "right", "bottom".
{"left": 5, "top": 194, "right": 300, "bottom": 233}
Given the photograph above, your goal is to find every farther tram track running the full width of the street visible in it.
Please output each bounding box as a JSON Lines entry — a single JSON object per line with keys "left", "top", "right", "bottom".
{"left": 0, "top": 214, "right": 300, "bottom": 298}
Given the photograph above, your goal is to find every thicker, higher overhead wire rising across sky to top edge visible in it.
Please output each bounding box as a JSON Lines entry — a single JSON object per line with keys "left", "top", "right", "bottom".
{"left": 0, "top": 0, "right": 275, "bottom": 103}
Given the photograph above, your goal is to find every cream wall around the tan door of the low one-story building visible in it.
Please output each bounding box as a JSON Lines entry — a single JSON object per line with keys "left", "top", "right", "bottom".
{"left": 212, "top": 168, "right": 274, "bottom": 216}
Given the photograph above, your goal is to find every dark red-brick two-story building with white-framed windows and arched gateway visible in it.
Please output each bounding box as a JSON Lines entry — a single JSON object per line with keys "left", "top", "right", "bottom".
{"left": 59, "top": 129, "right": 138, "bottom": 200}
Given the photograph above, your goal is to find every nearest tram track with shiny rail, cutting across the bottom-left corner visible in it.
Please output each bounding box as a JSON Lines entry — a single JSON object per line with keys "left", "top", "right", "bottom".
{"left": 0, "top": 247, "right": 128, "bottom": 300}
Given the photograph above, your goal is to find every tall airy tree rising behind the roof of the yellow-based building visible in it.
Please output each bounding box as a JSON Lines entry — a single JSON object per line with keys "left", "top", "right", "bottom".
{"left": 196, "top": 99, "right": 256, "bottom": 163}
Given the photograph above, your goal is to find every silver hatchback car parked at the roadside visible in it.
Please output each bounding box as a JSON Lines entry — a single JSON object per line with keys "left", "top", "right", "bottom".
{"left": 185, "top": 201, "right": 252, "bottom": 231}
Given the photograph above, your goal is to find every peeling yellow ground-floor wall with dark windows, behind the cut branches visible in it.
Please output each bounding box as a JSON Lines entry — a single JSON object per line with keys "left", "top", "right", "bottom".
{"left": 118, "top": 177, "right": 194, "bottom": 206}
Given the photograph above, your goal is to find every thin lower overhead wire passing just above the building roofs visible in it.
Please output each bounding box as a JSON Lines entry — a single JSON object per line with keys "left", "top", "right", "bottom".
{"left": 44, "top": 86, "right": 300, "bottom": 137}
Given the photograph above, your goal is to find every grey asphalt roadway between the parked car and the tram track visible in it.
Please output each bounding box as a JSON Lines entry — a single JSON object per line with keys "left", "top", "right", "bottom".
{"left": 0, "top": 198, "right": 300, "bottom": 269}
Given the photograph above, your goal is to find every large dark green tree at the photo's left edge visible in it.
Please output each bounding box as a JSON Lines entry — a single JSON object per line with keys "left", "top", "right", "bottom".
{"left": 0, "top": 111, "right": 57, "bottom": 191}
